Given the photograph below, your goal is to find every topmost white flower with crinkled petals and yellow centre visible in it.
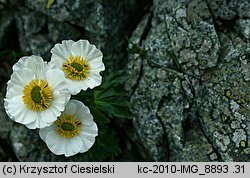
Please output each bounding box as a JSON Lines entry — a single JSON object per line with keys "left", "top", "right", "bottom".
{"left": 51, "top": 40, "right": 105, "bottom": 95}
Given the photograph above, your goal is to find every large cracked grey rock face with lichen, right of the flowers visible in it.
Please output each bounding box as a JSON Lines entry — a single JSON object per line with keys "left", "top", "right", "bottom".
{"left": 126, "top": 0, "right": 250, "bottom": 161}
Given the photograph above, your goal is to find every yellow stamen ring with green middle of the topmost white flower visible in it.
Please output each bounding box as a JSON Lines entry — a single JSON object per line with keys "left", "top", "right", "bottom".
{"left": 62, "top": 56, "right": 90, "bottom": 80}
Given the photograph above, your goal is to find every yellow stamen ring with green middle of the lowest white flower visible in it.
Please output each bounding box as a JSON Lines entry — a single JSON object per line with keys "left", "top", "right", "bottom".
{"left": 55, "top": 114, "right": 82, "bottom": 138}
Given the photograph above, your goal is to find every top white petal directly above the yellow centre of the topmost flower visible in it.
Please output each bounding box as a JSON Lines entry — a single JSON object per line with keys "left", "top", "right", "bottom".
{"left": 71, "top": 40, "right": 92, "bottom": 59}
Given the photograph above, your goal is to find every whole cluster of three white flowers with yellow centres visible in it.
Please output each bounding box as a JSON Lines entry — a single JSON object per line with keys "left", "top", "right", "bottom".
{"left": 4, "top": 40, "right": 105, "bottom": 157}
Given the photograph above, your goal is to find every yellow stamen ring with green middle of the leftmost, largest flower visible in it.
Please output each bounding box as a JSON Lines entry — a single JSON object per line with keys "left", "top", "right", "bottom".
{"left": 23, "top": 80, "right": 52, "bottom": 111}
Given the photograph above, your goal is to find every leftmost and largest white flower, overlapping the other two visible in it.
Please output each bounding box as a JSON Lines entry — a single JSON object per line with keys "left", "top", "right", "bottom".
{"left": 4, "top": 56, "right": 70, "bottom": 129}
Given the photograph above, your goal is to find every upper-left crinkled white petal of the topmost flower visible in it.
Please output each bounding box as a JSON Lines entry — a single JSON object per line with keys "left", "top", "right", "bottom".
{"left": 51, "top": 40, "right": 74, "bottom": 63}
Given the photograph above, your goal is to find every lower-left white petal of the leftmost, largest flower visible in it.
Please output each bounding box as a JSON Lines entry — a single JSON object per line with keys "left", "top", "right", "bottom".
{"left": 5, "top": 96, "right": 36, "bottom": 124}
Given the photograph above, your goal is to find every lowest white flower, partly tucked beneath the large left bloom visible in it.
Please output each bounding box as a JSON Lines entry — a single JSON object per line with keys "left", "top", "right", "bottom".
{"left": 39, "top": 100, "right": 98, "bottom": 157}
